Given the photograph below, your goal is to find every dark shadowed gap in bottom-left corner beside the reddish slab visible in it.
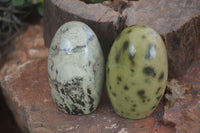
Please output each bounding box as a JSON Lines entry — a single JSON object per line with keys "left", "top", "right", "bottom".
{"left": 0, "top": 86, "right": 23, "bottom": 133}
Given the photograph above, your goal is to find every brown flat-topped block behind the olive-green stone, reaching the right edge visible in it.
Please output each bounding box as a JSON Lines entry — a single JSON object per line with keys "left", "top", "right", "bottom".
{"left": 124, "top": 0, "right": 200, "bottom": 77}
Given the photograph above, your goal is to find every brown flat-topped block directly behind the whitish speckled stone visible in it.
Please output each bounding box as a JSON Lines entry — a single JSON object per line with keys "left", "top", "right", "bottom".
{"left": 44, "top": 0, "right": 123, "bottom": 58}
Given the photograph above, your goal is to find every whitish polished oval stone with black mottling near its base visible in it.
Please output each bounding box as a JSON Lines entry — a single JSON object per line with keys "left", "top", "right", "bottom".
{"left": 48, "top": 21, "right": 105, "bottom": 115}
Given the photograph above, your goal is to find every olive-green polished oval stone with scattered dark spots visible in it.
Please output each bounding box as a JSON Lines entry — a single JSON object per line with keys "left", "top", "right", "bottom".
{"left": 106, "top": 25, "right": 168, "bottom": 119}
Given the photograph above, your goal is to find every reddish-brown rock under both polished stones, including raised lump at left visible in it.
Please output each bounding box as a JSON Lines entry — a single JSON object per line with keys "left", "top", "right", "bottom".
{"left": 0, "top": 23, "right": 175, "bottom": 133}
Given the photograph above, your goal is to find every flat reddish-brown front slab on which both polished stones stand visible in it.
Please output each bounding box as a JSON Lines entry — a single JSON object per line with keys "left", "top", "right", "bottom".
{"left": 1, "top": 59, "right": 174, "bottom": 133}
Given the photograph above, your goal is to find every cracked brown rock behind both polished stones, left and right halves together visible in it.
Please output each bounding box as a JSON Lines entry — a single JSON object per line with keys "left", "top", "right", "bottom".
{"left": 44, "top": 0, "right": 200, "bottom": 77}
